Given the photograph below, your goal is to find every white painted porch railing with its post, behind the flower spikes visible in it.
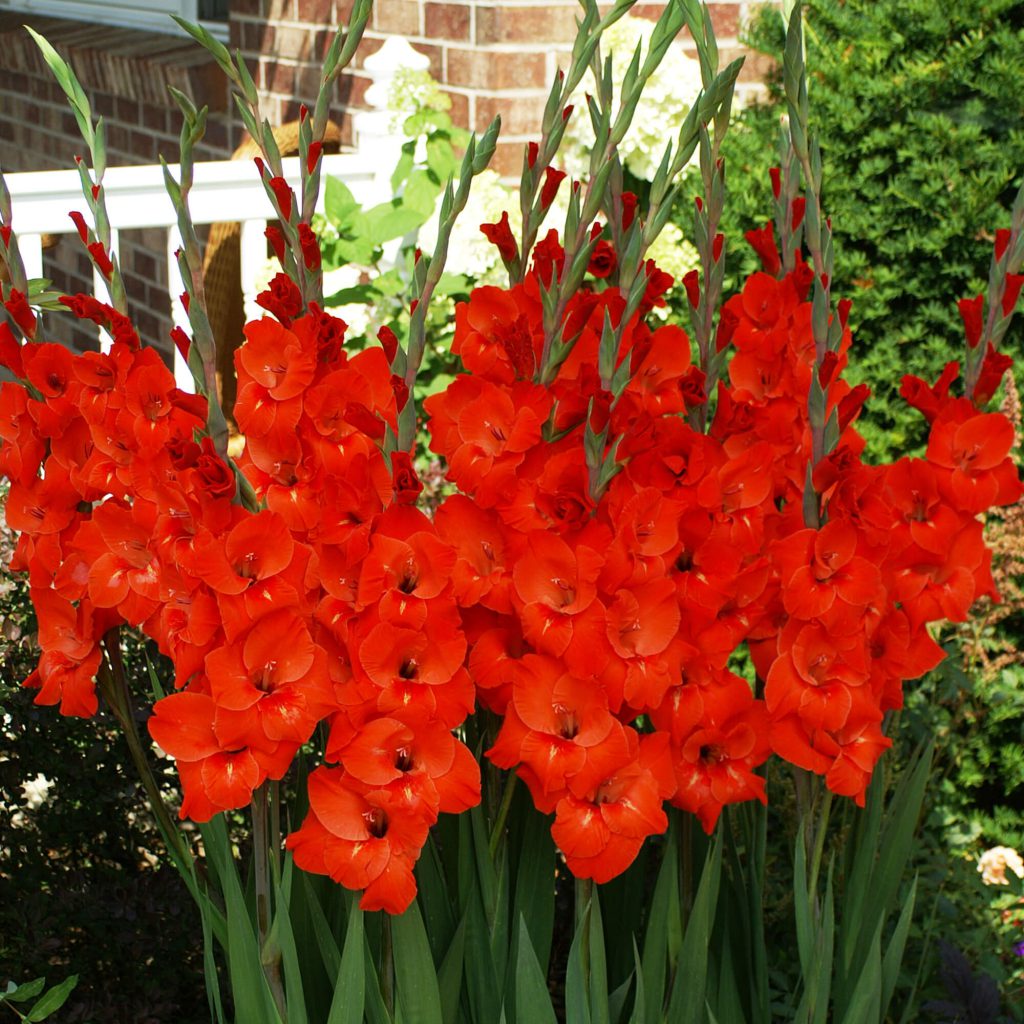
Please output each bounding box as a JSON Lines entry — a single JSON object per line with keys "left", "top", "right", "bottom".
{"left": 6, "top": 39, "right": 429, "bottom": 391}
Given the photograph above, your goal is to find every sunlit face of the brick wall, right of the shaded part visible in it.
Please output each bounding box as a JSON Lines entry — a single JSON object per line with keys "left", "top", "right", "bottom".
{"left": 231, "top": 0, "right": 764, "bottom": 175}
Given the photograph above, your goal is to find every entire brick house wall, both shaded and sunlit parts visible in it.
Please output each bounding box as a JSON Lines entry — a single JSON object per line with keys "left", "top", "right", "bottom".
{"left": 0, "top": 0, "right": 764, "bottom": 350}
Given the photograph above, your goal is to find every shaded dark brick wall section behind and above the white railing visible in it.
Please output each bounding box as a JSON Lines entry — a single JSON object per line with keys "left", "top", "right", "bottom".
{"left": 0, "top": 14, "right": 234, "bottom": 353}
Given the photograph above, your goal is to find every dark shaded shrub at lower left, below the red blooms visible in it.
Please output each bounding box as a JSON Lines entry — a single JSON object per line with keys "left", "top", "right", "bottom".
{"left": 0, "top": 488, "right": 209, "bottom": 1024}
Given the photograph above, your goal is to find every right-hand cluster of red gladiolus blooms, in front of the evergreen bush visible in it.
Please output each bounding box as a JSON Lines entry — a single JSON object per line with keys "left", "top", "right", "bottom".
{"left": 426, "top": 207, "right": 1020, "bottom": 882}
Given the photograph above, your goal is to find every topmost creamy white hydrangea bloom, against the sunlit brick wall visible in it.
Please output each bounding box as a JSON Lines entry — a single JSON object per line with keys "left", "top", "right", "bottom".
{"left": 559, "top": 15, "right": 700, "bottom": 181}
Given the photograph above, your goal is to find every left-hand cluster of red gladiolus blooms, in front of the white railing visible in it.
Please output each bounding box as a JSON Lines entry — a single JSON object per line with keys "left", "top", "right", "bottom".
{"left": 0, "top": 282, "right": 479, "bottom": 912}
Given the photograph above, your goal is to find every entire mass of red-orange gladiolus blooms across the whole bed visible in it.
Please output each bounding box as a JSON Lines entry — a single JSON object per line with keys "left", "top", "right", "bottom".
{"left": 0, "top": 184, "right": 1020, "bottom": 912}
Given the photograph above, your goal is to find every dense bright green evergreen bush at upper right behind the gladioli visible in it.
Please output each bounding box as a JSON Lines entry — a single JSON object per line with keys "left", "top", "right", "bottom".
{"left": 692, "top": 0, "right": 1024, "bottom": 459}
